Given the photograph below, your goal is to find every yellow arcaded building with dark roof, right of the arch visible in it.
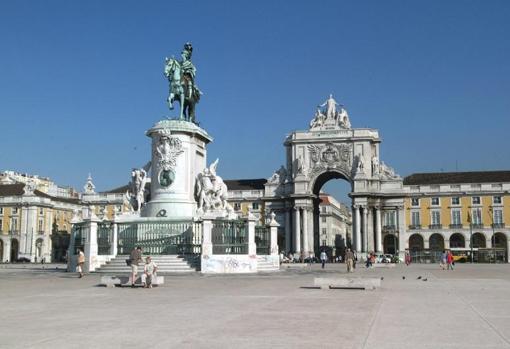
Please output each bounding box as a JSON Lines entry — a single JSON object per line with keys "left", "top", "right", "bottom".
{"left": 404, "top": 171, "right": 510, "bottom": 262}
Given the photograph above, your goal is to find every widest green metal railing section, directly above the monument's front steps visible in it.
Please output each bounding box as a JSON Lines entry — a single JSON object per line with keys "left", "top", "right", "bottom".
{"left": 117, "top": 221, "right": 202, "bottom": 255}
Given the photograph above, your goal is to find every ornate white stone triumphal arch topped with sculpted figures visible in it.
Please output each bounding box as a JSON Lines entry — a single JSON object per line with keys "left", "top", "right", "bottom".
{"left": 265, "top": 95, "right": 405, "bottom": 257}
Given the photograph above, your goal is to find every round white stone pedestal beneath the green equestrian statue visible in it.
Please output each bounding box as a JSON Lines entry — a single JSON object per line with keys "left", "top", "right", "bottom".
{"left": 142, "top": 120, "right": 212, "bottom": 219}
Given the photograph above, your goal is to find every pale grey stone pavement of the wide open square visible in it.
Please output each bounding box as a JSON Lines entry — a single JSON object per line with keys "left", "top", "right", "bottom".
{"left": 0, "top": 264, "right": 510, "bottom": 349}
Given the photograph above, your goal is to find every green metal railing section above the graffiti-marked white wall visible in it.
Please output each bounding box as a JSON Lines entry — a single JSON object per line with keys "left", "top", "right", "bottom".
{"left": 211, "top": 220, "right": 248, "bottom": 254}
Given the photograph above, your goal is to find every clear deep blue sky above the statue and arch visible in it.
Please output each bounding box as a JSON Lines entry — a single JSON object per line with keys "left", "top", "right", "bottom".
{"left": 0, "top": 0, "right": 510, "bottom": 200}
